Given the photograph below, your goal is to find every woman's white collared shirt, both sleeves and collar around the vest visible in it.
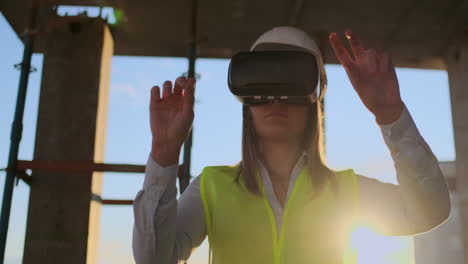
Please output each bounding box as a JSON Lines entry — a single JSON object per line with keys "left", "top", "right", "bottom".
{"left": 132, "top": 103, "right": 450, "bottom": 264}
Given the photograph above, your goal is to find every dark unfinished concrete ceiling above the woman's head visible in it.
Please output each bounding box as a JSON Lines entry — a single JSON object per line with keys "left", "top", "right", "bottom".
{"left": 0, "top": 0, "right": 468, "bottom": 69}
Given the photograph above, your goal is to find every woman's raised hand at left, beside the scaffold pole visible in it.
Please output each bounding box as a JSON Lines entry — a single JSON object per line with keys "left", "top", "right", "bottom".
{"left": 150, "top": 76, "right": 195, "bottom": 166}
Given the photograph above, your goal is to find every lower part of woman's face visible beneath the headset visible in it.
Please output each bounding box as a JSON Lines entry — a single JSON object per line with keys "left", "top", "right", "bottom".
{"left": 250, "top": 102, "right": 307, "bottom": 141}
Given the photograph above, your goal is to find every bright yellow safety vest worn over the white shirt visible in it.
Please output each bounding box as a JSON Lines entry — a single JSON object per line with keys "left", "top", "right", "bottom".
{"left": 200, "top": 165, "right": 358, "bottom": 264}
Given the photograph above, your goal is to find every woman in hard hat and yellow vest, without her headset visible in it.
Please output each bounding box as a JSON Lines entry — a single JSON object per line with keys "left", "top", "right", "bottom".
{"left": 133, "top": 27, "right": 450, "bottom": 264}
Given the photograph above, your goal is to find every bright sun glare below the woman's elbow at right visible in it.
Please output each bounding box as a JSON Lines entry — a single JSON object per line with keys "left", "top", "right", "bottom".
{"left": 345, "top": 225, "right": 415, "bottom": 264}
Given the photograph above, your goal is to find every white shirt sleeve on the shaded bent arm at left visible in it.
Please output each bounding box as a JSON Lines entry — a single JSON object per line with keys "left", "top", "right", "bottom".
{"left": 132, "top": 155, "right": 206, "bottom": 264}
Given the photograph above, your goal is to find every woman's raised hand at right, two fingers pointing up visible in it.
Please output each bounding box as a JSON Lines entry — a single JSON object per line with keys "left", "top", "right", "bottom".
{"left": 329, "top": 29, "right": 404, "bottom": 125}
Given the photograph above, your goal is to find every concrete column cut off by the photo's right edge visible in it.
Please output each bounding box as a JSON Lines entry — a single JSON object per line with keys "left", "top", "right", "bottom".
{"left": 446, "top": 32, "right": 468, "bottom": 263}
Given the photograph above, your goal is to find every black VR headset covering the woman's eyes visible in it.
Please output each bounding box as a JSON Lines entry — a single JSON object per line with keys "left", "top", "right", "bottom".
{"left": 228, "top": 50, "right": 323, "bottom": 105}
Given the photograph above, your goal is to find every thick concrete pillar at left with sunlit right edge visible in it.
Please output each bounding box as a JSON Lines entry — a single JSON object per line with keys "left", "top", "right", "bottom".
{"left": 23, "top": 18, "right": 113, "bottom": 264}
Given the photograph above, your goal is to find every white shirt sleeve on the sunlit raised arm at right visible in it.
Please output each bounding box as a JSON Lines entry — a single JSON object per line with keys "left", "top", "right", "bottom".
{"left": 358, "top": 102, "right": 450, "bottom": 235}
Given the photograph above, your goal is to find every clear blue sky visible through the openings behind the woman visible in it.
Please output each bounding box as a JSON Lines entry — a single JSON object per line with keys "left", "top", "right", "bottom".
{"left": 0, "top": 10, "right": 455, "bottom": 264}
